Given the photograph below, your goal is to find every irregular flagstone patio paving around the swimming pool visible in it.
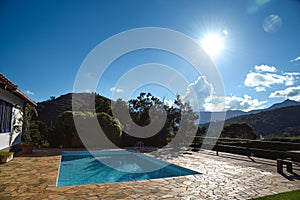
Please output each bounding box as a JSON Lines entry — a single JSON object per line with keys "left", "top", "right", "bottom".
{"left": 0, "top": 149, "right": 300, "bottom": 200}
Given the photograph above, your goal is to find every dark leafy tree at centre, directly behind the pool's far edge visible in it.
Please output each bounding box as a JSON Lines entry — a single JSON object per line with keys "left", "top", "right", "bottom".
{"left": 113, "top": 92, "right": 172, "bottom": 146}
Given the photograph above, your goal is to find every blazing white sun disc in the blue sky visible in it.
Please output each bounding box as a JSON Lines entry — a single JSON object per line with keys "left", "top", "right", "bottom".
{"left": 201, "top": 34, "right": 224, "bottom": 57}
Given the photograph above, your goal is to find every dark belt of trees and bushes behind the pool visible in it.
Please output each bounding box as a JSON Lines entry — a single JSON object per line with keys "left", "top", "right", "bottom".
{"left": 32, "top": 93, "right": 198, "bottom": 147}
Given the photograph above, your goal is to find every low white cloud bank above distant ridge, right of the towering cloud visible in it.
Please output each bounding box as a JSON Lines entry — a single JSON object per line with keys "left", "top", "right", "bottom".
{"left": 205, "top": 94, "right": 267, "bottom": 112}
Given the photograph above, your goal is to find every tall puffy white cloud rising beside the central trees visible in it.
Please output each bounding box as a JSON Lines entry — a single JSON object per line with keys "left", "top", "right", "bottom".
{"left": 182, "top": 76, "right": 214, "bottom": 112}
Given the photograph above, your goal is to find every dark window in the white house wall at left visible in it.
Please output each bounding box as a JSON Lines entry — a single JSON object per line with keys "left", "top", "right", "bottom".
{"left": 0, "top": 100, "right": 12, "bottom": 133}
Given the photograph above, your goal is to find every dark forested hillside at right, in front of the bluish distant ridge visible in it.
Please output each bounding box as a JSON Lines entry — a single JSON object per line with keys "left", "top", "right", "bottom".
{"left": 226, "top": 105, "right": 300, "bottom": 137}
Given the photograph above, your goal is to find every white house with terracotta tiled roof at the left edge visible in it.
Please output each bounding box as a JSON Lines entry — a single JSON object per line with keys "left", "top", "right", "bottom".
{"left": 0, "top": 73, "right": 37, "bottom": 151}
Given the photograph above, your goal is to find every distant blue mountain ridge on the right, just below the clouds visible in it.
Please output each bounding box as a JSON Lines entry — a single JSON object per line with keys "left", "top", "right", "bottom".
{"left": 199, "top": 99, "right": 300, "bottom": 124}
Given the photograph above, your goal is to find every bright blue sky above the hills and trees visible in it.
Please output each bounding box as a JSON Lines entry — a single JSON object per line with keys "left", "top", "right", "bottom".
{"left": 0, "top": 0, "right": 300, "bottom": 111}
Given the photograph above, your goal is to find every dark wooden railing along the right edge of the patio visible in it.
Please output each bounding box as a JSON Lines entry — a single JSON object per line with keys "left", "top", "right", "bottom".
{"left": 191, "top": 136, "right": 300, "bottom": 161}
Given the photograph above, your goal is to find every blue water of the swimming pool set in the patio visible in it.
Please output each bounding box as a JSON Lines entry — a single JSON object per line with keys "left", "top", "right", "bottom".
{"left": 57, "top": 151, "right": 199, "bottom": 186}
